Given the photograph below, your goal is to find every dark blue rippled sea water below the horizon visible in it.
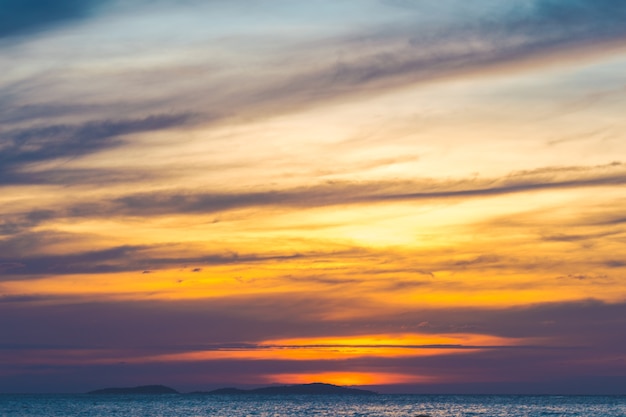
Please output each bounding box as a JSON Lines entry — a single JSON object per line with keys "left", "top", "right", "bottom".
{"left": 0, "top": 394, "right": 626, "bottom": 417}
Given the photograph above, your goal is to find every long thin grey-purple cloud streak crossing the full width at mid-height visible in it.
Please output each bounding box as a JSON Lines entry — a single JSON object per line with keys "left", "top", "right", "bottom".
{"left": 0, "top": 162, "right": 626, "bottom": 234}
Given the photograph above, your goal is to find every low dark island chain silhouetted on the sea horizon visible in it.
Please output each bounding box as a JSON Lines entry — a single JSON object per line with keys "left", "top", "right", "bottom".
{"left": 87, "top": 382, "right": 377, "bottom": 395}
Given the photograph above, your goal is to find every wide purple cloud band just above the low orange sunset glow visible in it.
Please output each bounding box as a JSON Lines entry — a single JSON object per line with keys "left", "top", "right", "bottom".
{"left": 0, "top": 293, "right": 626, "bottom": 353}
